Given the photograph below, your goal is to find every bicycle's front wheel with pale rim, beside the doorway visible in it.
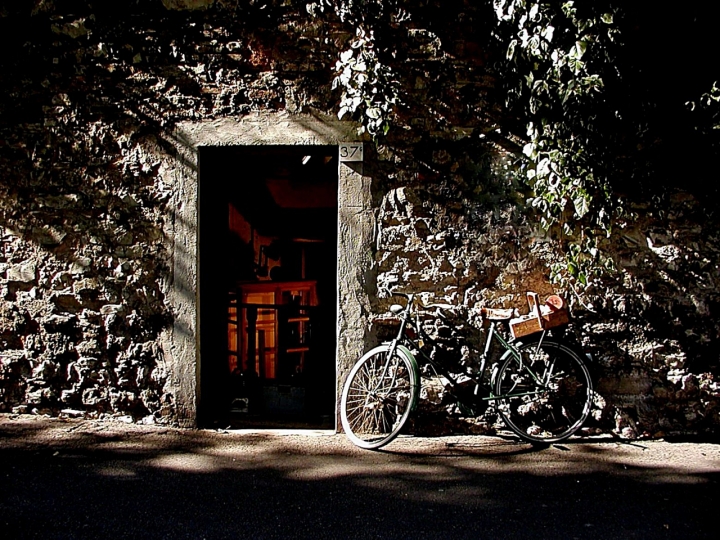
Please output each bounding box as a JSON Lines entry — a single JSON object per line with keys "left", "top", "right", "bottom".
{"left": 340, "top": 345, "right": 418, "bottom": 449}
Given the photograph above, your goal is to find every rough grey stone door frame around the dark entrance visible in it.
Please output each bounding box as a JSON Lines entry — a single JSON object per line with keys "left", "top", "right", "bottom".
{"left": 157, "top": 112, "right": 376, "bottom": 428}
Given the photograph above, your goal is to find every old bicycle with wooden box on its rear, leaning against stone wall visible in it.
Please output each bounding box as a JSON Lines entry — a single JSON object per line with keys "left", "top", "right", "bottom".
{"left": 340, "top": 293, "right": 593, "bottom": 449}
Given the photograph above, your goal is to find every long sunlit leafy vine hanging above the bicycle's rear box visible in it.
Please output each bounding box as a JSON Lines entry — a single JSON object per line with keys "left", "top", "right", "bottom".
{"left": 494, "top": 0, "right": 621, "bottom": 287}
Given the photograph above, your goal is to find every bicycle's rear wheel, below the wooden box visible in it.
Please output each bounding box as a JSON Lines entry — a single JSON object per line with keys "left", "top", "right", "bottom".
{"left": 495, "top": 340, "right": 593, "bottom": 443}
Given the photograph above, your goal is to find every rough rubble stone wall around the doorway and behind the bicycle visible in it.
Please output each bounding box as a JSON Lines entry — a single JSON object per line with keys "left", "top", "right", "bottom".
{"left": 0, "top": 0, "right": 720, "bottom": 438}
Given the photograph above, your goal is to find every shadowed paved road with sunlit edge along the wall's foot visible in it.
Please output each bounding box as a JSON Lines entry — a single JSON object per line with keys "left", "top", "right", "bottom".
{"left": 0, "top": 415, "right": 720, "bottom": 539}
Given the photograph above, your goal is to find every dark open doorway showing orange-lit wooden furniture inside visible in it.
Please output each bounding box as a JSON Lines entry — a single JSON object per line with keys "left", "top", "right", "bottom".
{"left": 198, "top": 146, "right": 338, "bottom": 428}
